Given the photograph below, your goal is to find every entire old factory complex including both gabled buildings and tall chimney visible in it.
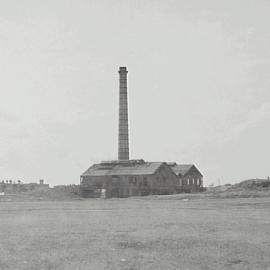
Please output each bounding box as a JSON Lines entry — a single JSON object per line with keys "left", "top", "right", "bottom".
{"left": 80, "top": 67, "right": 202, "bottom": 198}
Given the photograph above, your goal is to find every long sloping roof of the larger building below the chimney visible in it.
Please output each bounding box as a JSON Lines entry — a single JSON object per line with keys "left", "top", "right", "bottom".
{"left": 82, "top": 161, "right": 167, "bottom": 176}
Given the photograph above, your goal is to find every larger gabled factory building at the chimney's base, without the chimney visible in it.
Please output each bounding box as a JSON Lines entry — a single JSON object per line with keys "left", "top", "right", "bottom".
{"left": 80, "top": 159, "right": 179, "bottom": 198}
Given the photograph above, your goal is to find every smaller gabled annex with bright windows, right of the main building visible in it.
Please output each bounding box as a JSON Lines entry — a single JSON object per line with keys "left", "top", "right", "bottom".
{"left": 168, "top": 163, "right": 203, "bottom": 191}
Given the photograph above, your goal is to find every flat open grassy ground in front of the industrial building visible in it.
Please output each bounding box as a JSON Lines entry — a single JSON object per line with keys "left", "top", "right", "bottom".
{"left": 0, "top": 197, "right": 270, "bottom": 270}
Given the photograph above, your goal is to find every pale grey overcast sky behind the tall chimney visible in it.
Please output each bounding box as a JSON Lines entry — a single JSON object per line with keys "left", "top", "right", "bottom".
{"left": 0, "top": 0, "right": 270, "bottom": 186}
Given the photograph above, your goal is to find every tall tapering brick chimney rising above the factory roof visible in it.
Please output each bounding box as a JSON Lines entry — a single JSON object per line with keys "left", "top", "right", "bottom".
{"left": 118, "top": 67, "right": 129, "bottom": 160}
